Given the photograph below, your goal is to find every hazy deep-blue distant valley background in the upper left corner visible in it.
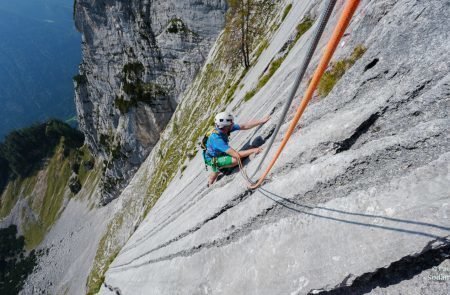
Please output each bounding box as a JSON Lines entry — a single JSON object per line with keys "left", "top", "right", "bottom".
{"left": 0, "top": 0, "right": 81, "bottom": 140}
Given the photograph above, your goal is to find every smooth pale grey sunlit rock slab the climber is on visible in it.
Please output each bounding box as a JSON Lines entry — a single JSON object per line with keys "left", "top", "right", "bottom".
{"left": 100, "top": 0, "right": 450, "bottom": 295}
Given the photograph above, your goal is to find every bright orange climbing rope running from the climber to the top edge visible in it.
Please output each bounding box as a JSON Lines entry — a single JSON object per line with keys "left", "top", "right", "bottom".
{"left": 243, "top": 0, "right": 360, "bottom": 189}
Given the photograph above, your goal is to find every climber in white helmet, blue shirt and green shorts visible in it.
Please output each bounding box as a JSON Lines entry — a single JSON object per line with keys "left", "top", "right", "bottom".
{"left": 203, "top": 112, "right": 270, "bottom": 186}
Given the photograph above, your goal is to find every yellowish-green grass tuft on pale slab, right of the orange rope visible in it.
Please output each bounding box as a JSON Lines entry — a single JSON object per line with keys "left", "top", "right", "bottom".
{"left": 317, "top": 45, "right": 366, "bottom": 97}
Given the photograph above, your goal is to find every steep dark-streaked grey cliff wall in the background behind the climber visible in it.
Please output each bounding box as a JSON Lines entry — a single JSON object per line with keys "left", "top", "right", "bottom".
{"left": 74, "top": 0, "right": 226, "bottom": 204}
